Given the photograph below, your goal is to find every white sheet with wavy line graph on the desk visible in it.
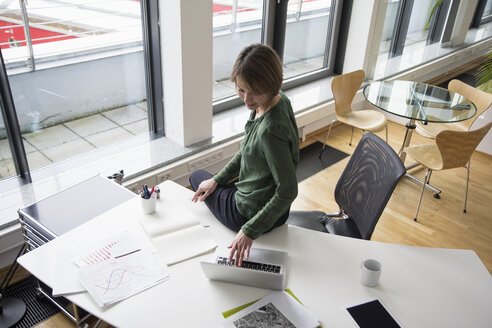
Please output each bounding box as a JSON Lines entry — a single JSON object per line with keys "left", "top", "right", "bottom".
{"left": 79, "top": 232, "right": 169, "bottom": 306}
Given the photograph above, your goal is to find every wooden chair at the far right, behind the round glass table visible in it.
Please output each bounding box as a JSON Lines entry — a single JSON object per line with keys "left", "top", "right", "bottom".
{"left": 416, "top": 80, "right": 492, "bottom": 139}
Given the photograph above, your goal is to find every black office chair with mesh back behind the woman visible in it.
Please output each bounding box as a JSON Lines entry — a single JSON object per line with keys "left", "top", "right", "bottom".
{"left": 287, "top": 133, "right": 406, "bottom": 240}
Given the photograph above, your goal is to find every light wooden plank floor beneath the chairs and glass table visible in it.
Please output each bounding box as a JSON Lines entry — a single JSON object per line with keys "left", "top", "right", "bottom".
{"left": 19, "top": 122, "right": 492, "bottom": 328}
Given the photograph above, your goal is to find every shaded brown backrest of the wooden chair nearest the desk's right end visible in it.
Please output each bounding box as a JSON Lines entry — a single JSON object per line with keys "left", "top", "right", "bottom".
{"left": 436, "top": 122, "right": 492, "bottom": 170}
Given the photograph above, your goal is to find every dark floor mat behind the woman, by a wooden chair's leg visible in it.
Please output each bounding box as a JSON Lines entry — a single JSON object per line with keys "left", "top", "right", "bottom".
{"left": 296, "top": 141, "right": 349, "bottom": 182}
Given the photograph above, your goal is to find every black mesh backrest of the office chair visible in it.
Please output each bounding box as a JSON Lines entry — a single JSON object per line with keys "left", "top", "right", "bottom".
{"left": 335, "top": 133, "right": 406, "bottom": 239}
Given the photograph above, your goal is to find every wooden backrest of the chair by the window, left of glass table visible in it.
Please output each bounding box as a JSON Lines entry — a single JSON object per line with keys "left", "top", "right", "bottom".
{"left": 331, "top": 70, "right": 366, "bottom": 116}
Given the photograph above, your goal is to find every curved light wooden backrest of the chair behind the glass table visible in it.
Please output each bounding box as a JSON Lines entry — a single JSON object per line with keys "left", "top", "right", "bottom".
{"left": 448, "top": 79, "right": 492, "bottom": 130}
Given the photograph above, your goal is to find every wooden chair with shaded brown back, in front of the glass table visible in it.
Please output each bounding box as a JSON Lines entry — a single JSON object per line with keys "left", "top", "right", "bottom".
{"left": 405, "top": 122, "right": 492, "bottom": 221}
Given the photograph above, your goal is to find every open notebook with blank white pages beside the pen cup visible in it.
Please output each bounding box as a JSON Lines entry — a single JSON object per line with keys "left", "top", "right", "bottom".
{"left": 140, "top": 206, "right": 217, "bottom": 265}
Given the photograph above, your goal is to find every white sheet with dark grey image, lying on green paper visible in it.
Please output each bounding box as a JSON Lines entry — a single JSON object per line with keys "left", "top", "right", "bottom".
{"left": 223, "top": 291, "right": 320, "bottom": 328}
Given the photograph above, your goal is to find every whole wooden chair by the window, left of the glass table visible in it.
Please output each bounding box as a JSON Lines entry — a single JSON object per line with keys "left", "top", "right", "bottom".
{"left": 319, "top": 70, "right": 388, "bottom": 158}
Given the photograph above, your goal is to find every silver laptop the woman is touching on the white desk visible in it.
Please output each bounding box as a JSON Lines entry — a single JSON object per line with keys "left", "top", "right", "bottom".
{"left": 200, "top": 247, "right": 288, "bottom": 290}
